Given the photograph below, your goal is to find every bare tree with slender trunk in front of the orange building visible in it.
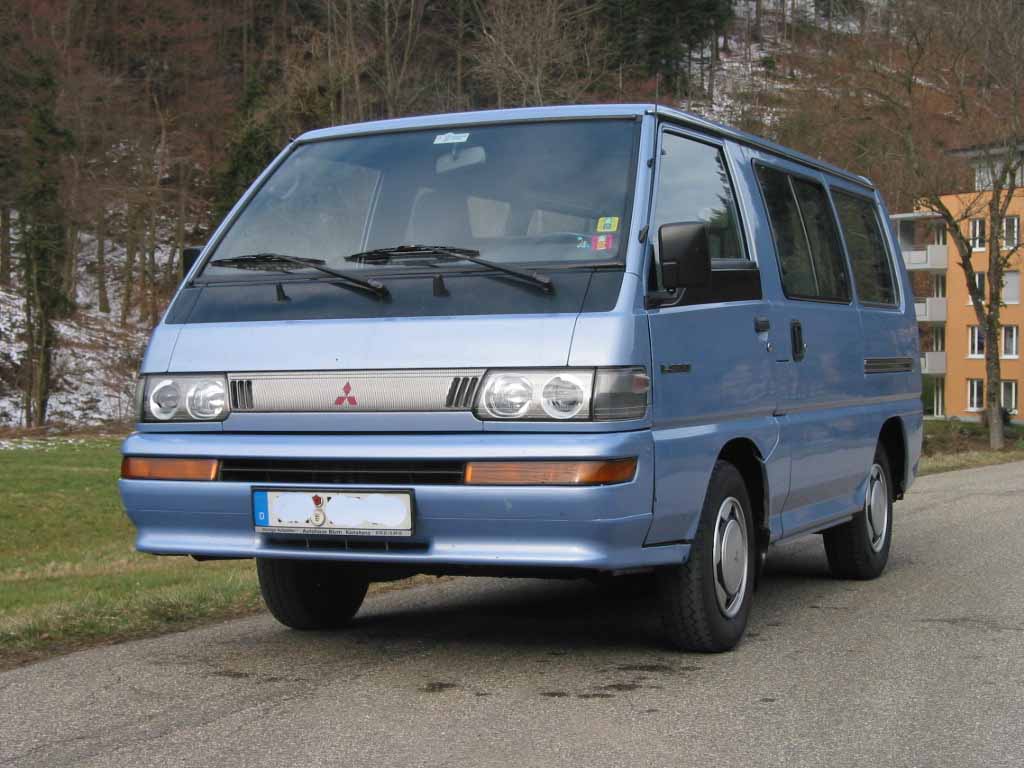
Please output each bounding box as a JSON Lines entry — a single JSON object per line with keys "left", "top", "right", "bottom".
{"left": 818, "top": 0, "right": 1024, "bottom": 449}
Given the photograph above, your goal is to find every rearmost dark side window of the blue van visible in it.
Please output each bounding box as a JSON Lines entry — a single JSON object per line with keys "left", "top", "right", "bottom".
{"left": 833, "top": 189, "right": 899, "bottom": 306}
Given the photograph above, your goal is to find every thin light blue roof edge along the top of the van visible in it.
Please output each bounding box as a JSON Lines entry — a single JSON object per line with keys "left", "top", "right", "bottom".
{"left": 296, "top": 103, "right": 874, "bottom": 189}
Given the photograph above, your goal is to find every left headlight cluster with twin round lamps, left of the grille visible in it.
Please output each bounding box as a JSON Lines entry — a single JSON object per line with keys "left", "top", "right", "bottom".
{"left": 135, "top": 375, "right": 230, "bottom": 422}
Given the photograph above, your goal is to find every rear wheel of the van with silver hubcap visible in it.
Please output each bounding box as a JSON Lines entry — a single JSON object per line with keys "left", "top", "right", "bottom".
{"left": 822, "top": 445, "right": 893, "bottom": 581}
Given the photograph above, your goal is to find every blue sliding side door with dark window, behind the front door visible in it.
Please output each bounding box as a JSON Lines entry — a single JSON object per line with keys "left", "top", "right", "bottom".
{"left": 754, "top": 157, "right": 865, "bottom": 536}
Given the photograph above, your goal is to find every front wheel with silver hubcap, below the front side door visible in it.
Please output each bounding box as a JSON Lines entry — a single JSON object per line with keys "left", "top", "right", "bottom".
{"left": 657, "top": 461, "right": 758, "bottom": 653}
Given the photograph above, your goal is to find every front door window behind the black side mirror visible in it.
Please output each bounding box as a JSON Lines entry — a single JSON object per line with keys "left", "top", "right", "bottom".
{"left": 650, "top": 133, "right": 748, "bottom": 259}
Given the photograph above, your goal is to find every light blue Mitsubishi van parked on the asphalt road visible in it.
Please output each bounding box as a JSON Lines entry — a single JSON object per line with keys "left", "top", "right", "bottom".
{"left": 120, "top": 104, "right": 922, "bottom": 651}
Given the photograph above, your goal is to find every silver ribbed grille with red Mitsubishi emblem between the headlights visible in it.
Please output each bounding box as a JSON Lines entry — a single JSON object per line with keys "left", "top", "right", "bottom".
{"left": 228, "top": 369, "right": 483, "bottom": 413}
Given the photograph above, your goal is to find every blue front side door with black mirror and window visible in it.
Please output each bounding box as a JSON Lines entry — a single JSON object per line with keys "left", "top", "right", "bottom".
{"left": 647, "top": 126, "right": 778, "bottom": 544}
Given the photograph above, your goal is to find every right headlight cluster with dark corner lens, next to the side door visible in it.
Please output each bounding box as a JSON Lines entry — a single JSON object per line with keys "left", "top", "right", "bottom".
{"left": 475, "top": 367, "right": 650, "bottom": 421}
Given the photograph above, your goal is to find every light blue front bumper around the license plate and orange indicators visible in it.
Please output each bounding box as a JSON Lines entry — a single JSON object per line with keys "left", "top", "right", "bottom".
{"left": 120, "top": 430, "right": 688, "bottom": 570}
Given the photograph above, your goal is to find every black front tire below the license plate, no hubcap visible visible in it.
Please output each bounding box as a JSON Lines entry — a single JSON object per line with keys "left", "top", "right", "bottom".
{"left": 256, "top": 558, "right": 370, "bottom": 630}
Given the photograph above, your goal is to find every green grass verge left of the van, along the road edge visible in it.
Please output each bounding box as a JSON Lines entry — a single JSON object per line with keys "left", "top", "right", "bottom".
{"left": 0, "top": 437, "right": 261, "bottom": 669}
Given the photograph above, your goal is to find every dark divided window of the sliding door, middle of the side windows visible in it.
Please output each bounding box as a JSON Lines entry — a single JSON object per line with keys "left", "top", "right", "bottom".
{"left": 757, "top": 165, "right": 850, "bottom": 301}
